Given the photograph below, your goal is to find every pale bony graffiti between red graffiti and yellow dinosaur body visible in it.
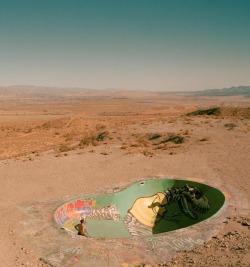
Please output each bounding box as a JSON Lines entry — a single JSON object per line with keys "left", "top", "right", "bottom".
{"left": 87, "top": 205, "right": 120, "bottom": 221}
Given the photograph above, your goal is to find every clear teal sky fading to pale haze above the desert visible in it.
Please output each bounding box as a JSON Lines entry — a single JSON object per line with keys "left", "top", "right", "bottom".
{"left": 0, "top": 0, "right": 250, "bottom": 91}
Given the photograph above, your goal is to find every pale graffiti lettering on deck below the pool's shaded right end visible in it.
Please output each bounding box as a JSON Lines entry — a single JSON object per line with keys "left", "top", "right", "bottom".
{"left": 145, "top": 236, "right": 204, "bottom": 251}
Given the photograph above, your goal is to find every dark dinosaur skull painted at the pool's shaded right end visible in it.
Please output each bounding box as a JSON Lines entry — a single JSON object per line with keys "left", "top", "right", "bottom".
{"left": 183, "top": 185, "right": 211, "bottom": 213}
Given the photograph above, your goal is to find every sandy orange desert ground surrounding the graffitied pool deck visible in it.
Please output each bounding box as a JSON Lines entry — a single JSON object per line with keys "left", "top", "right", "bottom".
{"left": 0, "top": 92, "right": 250, "bottom": 267}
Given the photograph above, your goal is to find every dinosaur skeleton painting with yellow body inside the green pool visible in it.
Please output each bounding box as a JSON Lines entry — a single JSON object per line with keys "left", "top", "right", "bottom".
{"left": 124, "top": 185, "right": 211, "bottom": 236}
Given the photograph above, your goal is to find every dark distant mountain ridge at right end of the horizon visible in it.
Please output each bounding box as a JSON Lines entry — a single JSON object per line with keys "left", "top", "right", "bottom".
{"left": 194, "top": 86, "right": 250, "bottom": 97}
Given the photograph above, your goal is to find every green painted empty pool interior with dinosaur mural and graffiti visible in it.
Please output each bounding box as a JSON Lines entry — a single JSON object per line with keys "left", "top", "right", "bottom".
{"left": 54, "top": 179, "right": 225, "bottom": 238}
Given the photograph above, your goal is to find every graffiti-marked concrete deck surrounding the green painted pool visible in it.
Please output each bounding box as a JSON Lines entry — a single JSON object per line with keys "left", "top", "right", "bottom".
{"left": 16, "top": 176, "right": 248, "bottom": 267}
